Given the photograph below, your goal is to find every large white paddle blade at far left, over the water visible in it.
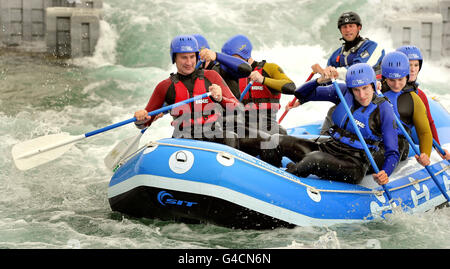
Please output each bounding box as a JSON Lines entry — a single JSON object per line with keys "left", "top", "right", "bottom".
{"left": 11, "top": 133, "right": 84, "bottom": 170}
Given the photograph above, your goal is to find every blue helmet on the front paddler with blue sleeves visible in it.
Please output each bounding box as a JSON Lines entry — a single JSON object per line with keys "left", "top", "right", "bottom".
{"left": 345, "top": 63, "right": 377, "bottom": 90}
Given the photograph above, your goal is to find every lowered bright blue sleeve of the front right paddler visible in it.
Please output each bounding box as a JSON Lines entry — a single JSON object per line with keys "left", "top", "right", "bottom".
{"left": 379, "top": 102, "right": 400, "bottom": 176}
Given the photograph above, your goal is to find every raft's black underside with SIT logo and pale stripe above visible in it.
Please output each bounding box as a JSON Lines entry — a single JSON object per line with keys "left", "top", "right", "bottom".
{"left": 108, "top": 175, "right": 366, "bottom": 228}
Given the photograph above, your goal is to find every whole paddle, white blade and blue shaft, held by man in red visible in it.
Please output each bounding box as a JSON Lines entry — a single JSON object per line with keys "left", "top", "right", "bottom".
{"left": 11, "top": 92, "right": 211, "bottom": 170}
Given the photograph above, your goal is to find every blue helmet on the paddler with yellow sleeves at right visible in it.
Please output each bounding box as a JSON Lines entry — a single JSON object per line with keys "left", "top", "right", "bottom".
{"left": 381, "top": 51, "right": 409, "bottom": 79}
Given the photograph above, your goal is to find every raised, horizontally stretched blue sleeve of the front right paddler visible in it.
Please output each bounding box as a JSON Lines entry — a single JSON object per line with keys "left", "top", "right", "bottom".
{"left": 295, "top": 79, "right": 348, "bottom": 104}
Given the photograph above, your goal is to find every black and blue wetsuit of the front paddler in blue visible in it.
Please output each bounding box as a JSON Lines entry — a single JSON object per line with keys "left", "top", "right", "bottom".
{"left": 279, "top": 81, "right": 399, "bottom": 184}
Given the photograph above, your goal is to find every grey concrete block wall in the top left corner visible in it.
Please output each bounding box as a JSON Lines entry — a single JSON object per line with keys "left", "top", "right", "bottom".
{"left": 0, "top": 0, "right": 103, "bottom": 57}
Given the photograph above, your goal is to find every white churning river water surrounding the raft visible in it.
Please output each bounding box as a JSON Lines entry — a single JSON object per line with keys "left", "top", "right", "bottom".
{"left": 0, "top": 0, "right": 450, "bottom": 249}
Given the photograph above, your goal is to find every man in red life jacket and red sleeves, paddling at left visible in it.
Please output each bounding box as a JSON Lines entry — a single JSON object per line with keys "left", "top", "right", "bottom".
{"left": 134, "top": 35, "right": 239, "bottom": 148}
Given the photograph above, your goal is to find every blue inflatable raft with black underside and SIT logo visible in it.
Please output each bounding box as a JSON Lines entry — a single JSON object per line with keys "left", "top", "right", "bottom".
{"left": 108, "top": 99, "right": 450, "bottom": 229}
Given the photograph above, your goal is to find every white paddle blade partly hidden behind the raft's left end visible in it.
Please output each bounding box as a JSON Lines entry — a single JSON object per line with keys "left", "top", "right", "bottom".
{"left": 104, "top": 133, "right": 142, "bottom": 170}
